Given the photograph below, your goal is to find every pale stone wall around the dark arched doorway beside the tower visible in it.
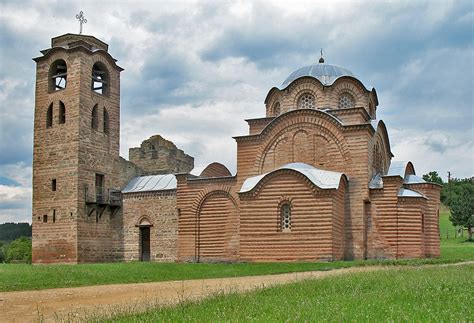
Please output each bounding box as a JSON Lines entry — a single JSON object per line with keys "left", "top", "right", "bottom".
{"left": 123, "top": 190, "right": 178, "bottom": 262}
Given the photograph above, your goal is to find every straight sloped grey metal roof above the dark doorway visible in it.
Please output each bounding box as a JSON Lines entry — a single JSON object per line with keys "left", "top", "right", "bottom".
{"left": 122, "top": 174, "right": 178, "bottom": 193}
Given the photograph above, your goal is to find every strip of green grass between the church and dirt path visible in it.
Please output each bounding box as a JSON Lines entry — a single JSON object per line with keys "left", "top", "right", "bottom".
{"left": 0, "top": 214, "right": 474, "bottom": 291}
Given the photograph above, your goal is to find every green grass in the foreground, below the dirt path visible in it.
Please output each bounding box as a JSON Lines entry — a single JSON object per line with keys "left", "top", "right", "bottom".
{"left": 107, "top": 265, "right": 474, "bottom": 322}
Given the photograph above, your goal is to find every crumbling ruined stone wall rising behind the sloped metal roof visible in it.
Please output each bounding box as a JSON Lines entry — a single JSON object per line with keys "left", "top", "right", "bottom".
{"left": 129, "top": 135, "right": 194, "bottom": 175}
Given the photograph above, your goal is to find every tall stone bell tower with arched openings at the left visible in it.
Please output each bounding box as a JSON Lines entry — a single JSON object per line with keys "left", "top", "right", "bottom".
{"left": 32, "top": 34, "right": 122, "bottom": 263}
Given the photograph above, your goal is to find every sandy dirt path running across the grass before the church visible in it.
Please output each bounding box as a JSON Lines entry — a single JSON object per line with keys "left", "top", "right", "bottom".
{"left": 0, "top": 261, "right": 474, "bottom": 322}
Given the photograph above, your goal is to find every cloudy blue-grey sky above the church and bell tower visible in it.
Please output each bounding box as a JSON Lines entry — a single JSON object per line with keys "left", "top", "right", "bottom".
{"left": 0, "top": 0, "right": 474, "bottom": 223}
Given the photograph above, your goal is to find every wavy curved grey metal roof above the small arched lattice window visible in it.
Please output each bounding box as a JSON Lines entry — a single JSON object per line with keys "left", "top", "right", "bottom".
{"left": 239, "top": 163, "right": 343, "bottom": 193}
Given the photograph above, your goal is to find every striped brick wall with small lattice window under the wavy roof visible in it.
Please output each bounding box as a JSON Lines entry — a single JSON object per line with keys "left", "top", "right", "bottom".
{"left": 240, "top": 170, "right": 344, "bottom": 261}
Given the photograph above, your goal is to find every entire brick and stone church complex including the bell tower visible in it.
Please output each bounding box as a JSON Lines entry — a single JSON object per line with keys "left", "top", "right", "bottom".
{"left": 32, "top": 34, "right": 440, "bottom": 263}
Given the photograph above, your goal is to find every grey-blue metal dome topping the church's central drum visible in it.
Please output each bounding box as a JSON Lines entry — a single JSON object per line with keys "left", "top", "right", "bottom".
{"left": 281, "top": 63, "right": 355, "bottom": 89}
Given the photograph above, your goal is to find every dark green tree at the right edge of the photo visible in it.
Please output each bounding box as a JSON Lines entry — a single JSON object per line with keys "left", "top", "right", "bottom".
{"left": 449, "top": 182, "right": 474, "bottom": 241}
